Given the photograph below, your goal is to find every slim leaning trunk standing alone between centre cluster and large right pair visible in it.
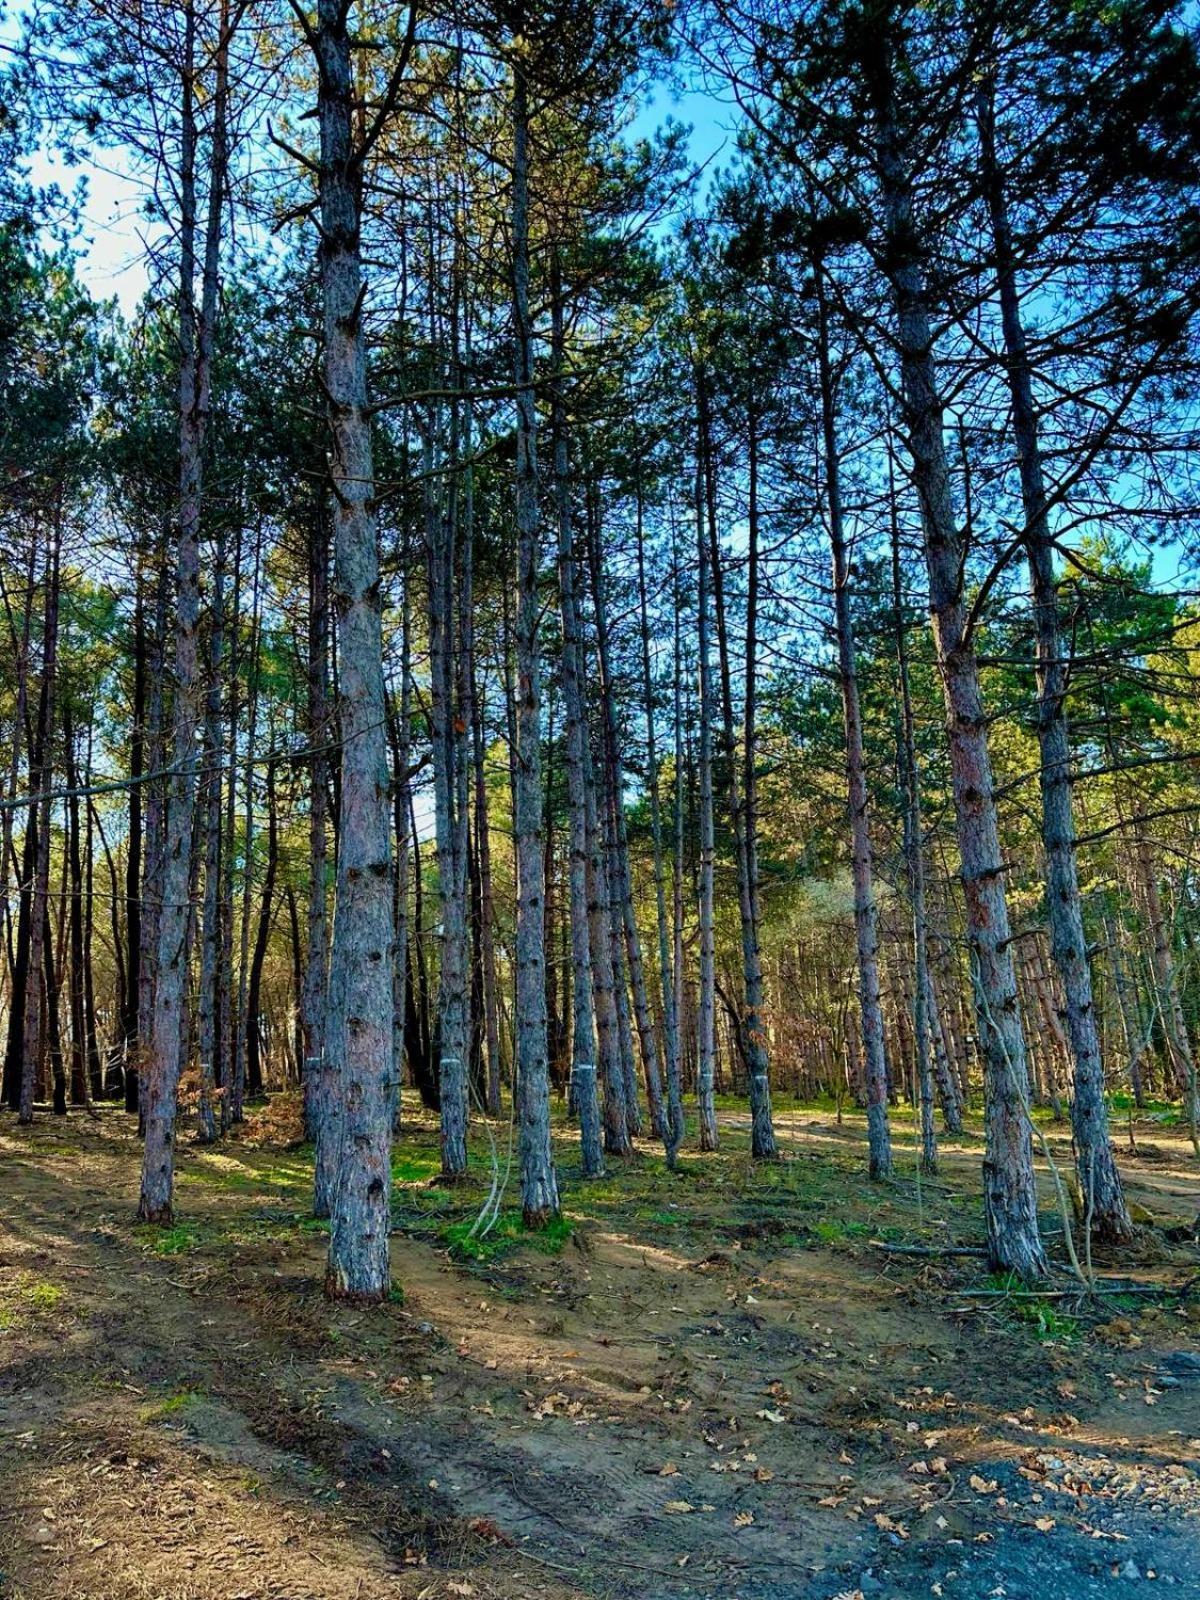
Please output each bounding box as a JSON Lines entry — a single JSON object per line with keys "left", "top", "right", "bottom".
{"left": 814, "top": 288, "right": 896, "bottom": 1179}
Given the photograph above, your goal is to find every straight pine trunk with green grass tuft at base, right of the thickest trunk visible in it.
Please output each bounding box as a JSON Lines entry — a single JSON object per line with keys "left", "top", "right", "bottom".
{"left": 512, "top": 53, "right": 558, "bottom": 1227}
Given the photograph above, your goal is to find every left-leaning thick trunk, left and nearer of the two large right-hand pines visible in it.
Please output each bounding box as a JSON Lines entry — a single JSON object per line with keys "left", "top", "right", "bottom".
{"left": 869, "top": 38, "right": 1046, "bottom": 1278}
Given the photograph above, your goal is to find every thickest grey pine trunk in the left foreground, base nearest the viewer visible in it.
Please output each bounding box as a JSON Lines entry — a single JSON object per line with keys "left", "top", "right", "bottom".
{"left": 314, "top": 0, "right": 394, "bottom": 1304}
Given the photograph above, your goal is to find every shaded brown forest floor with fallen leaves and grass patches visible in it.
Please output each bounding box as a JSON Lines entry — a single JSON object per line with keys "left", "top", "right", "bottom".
{"left": 0, "top": 1098, "right": 1200, "bottom": 1600}
